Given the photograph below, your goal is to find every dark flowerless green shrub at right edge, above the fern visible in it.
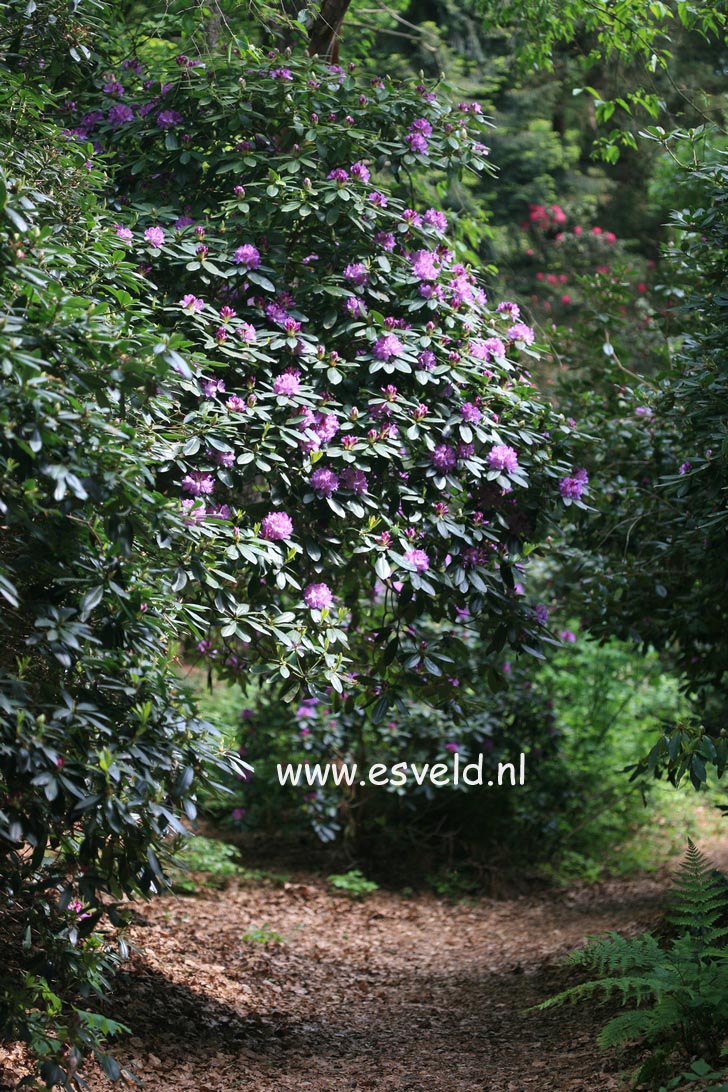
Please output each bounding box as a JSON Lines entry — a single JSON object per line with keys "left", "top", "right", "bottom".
{"left": 557, "top": 165, "right": 728, "bottom": 768}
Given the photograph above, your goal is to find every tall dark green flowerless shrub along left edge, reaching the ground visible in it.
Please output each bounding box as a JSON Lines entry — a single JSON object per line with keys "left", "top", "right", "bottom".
{"left": 0, "top": 80, "right": 242, "bottom": 1084}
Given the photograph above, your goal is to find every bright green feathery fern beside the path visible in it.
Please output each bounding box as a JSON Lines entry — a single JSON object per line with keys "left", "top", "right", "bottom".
{"left": 538, "top": 841, "right": 728, "bottom": 1080}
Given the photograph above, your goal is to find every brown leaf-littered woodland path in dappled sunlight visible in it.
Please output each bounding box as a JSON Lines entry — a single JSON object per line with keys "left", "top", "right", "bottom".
{"left": 0, "top": 874, "right": 676, "bottom": 1092}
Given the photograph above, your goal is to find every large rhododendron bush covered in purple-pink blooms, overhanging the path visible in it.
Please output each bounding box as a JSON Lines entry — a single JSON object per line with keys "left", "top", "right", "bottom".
{"left": 69, "top": 55, "right": 583, "bottom": 715}
